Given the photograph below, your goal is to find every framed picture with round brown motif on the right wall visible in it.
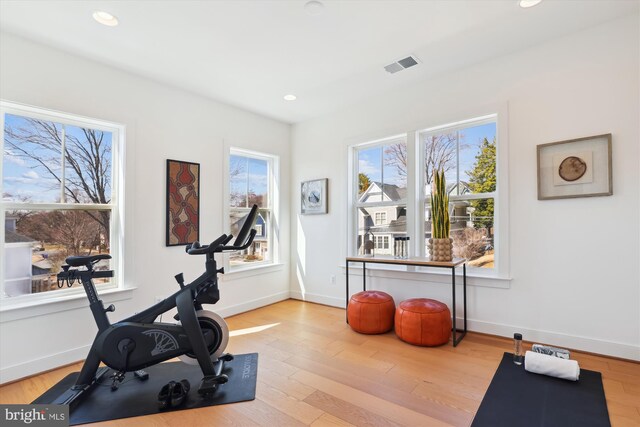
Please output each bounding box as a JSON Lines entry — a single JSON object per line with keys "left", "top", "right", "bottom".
{"left": 538, "top": 133, "right": 613, "bottom": 200}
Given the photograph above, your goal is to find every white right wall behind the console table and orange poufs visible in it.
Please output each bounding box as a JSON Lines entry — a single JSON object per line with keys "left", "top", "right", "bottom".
{"left": 291, "top": 16, "right": 640, "bottom": 360}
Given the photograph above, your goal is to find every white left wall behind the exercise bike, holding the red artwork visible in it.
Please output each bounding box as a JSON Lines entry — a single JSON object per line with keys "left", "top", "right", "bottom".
{"left": 0, "top": 34, "right": 290, "bottom": 383}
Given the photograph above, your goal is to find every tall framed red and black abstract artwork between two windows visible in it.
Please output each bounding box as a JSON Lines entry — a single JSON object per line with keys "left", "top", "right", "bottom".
{"left": 167, "top": 160, "right": 200, "bottom": 246}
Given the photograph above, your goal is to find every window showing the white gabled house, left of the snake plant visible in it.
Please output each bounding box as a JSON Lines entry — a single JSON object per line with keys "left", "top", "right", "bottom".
{"left": 353, "top": 137, "right": 407, "bottom": 255}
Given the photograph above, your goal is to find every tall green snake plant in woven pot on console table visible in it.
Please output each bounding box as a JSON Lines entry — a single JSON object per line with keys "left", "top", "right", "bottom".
{"left": 428, "top": 170, "right": 453, "bottom": 262}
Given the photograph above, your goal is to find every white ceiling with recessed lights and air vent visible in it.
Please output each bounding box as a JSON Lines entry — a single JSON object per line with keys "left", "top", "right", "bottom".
{"left": 0, "top": 0, "right": 640, "bottom": 123}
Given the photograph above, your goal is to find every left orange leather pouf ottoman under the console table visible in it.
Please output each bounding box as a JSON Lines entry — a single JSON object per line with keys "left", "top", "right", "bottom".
{"left": 347, "top": 291, "right": 396, "bottom": 334}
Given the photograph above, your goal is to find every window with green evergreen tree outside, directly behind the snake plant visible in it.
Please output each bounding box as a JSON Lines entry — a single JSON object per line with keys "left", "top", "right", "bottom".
{"left": 418, "top": 117, "right": 497, "bottom": 268}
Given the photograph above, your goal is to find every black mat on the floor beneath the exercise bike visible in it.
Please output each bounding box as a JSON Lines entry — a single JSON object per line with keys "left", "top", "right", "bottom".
{"left": 32, "top": 353, "right": 258, "bottom": 425}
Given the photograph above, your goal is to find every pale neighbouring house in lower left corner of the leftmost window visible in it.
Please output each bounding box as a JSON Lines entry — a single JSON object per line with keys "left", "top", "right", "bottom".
{"left": 4, "top": 215, "right": 36, "bottom": 297}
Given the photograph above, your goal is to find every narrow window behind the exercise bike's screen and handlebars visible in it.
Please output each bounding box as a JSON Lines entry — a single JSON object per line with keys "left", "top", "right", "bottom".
{"left": 228, "top": 149, "right": 277, "bottom": 269}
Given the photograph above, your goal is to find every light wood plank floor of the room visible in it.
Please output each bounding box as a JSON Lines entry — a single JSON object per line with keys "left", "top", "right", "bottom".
{"left": 0, "top": 300, "right": 640, "bottom": 427}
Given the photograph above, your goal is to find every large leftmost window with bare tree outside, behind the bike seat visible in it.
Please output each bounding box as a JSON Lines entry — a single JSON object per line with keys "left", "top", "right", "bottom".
{"left": 0, "top": 102, "right": 124, "bottom": 301}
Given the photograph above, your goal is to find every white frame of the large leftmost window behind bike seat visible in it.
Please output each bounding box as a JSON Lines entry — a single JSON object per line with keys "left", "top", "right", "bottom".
{"left": 0, "top": 100, "right": 125, "bottom": 312}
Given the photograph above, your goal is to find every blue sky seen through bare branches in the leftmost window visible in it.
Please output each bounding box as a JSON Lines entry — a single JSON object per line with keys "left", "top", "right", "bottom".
{"left": 2, "top": 114, "right": 112, "bottom": 203}
